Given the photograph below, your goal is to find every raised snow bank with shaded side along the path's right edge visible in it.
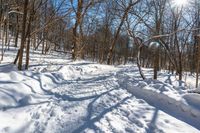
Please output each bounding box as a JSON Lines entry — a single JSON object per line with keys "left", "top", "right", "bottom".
{"left": 118, "top": 76, "right": 200, "bottom": 129}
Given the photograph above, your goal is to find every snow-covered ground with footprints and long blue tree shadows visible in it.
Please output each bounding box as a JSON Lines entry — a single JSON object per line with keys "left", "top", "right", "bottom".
{"left": 0, "top": 48, "right": 200, "bottom": 133}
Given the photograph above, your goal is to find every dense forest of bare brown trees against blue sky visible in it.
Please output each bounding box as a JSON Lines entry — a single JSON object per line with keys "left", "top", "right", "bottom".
{"left": 0, "top": 0, "right": 200, "bottom": 85}
